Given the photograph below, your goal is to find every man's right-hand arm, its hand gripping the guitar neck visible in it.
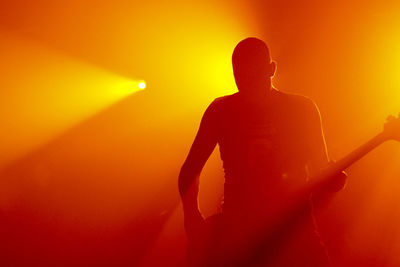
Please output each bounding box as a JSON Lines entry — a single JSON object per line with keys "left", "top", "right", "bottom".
{"left": 306, "top": 101, "right": 347, "bottom": 192}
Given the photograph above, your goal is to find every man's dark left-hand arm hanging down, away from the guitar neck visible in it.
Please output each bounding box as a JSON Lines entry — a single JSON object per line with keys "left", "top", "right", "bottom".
{"left": 178, "top": 103, "right": 217, "bottom": 235}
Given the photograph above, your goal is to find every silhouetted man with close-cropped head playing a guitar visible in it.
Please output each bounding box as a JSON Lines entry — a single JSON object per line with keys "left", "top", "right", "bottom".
{"left": 179, "top": 38, "right": 345, "bottom": 266}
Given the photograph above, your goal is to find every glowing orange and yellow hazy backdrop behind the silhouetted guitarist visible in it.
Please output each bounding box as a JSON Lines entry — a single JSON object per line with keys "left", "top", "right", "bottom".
{"left": 0, "top": 0, "right": 400, "bottom": 266}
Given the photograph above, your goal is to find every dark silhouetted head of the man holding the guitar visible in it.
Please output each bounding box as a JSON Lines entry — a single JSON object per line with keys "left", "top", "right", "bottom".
{"left": 232, "top": 37, "right": 276, "bottom": 94}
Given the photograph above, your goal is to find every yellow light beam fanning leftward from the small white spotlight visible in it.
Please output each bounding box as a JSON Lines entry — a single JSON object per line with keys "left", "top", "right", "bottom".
{"left": 0, "top": 32, "right": 141, "bottom": 170}
